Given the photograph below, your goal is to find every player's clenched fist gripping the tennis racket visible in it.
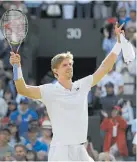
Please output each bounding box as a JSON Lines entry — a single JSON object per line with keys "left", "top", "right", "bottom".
{"left": 10, "top": 52, "right": 21, "bottom": 66}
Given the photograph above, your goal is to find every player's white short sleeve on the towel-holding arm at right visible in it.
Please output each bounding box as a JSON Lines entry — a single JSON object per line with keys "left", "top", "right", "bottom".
{"left": 79, "top": 75, "right": 93, "bottom": 92}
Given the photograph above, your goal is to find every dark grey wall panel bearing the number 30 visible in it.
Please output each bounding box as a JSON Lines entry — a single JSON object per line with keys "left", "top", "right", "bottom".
{"left": 30, "top": 19, "right": 104, "bottom": 62}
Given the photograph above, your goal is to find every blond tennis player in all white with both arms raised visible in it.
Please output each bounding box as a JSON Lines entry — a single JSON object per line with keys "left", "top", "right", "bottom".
{"left": 10, "top": 23, "right": 123, "bottom": 161}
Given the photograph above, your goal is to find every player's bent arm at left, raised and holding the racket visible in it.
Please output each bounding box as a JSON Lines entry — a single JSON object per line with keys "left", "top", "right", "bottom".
{"left": 10, "top": 52, "right": 41, "bottom": 99}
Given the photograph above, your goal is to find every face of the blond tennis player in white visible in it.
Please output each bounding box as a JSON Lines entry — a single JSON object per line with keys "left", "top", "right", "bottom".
{"left": 55, "top": 58, "right": 73, "bottom": 80}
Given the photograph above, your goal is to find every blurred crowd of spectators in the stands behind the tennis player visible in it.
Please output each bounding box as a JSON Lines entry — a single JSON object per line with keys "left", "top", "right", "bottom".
{"left": 0, "top": 0, "right": 137, "bottom": 161}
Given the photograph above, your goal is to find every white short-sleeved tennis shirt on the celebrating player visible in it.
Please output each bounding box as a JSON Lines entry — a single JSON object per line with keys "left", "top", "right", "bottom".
{"left": 39, "top": 75, "right": 93, "bottom": 146}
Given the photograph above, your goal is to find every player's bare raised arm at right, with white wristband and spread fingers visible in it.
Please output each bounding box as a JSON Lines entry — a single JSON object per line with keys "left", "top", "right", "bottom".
{"left": 91, "top": 23, "right": 124, "bottom": 87}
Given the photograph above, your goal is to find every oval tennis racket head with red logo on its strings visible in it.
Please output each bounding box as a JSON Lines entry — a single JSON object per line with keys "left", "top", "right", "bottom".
{"left": 1, "top": 9, "right": 28, "bottom": 47}
